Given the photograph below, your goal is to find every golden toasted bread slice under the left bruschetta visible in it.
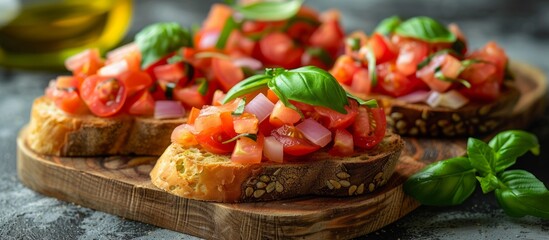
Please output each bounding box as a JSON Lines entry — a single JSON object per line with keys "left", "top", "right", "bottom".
{"left": 26, "top": 96, "right": 186, "bottom": 157}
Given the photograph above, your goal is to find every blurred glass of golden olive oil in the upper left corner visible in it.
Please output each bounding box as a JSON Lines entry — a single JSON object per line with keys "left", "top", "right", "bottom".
{"left": 0, "top": 0, "right": 132, "bottom": 69}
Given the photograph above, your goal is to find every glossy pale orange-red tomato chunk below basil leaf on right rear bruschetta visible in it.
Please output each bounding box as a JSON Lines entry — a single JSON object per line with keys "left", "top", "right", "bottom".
{"left": 396, "top": 40, "right": 429, "bottom": 76}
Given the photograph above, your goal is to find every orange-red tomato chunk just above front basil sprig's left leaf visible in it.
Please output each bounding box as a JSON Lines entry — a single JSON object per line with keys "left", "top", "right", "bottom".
{"left": 212, "top": 58, "right": 244, "bottom": 92}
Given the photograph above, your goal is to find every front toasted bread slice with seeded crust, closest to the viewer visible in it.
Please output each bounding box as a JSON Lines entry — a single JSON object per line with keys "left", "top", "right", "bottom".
{"left": 150, "top": 133, "right": 404, "bottom": 202}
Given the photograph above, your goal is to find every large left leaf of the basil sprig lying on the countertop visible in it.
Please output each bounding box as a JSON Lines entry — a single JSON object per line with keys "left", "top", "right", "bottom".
{"left": 404, "top": 157, "right": 476, "bottom": 206}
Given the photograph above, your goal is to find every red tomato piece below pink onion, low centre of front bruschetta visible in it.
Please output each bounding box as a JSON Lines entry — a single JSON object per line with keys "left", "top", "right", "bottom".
{"left": 271, "top": 125, "right": 320, "bottom": 156}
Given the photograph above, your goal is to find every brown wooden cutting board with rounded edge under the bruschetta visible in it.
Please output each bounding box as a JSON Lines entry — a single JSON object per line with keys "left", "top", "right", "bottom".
{"left": 17, "top": 63, "right": 547, "bottom": 239}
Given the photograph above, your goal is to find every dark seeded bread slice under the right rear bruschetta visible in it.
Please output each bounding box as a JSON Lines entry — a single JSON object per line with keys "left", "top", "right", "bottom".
{"left": 346, "top": 84, "right": 520, "bottom": 137}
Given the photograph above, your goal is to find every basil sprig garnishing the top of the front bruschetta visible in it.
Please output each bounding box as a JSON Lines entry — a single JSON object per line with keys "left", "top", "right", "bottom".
{"left": 223, "top": 66, "right": 374, "bottom": 113}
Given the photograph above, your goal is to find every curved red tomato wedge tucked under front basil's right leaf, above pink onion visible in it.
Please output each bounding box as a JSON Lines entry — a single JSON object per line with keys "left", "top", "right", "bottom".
{"left": 314, "top": 100, "right": 358, "bottom": 130}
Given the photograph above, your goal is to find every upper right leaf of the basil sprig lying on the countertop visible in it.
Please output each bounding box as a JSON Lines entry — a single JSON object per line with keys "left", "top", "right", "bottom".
{"left": 488, "top": 130, "right": 540, "bottom": 173}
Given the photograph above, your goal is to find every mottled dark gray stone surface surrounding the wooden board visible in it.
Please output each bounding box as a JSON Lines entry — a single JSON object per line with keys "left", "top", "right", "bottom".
{"left": 0, "top": 0, "right": 549, "bottom": 239}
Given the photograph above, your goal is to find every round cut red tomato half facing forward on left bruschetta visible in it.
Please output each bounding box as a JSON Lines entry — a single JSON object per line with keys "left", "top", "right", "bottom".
{"left": 80, "top": 75, "right": 128, "bottom": 117}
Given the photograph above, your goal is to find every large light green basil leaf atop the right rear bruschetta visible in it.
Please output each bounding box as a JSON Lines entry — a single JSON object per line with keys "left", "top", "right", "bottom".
{"left": 395, "top": 17, "right": 457, "bottom": 43}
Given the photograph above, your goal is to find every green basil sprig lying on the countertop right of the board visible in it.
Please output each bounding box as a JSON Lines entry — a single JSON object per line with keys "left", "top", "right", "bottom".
{"left": 404, "top": 130, "right": 549, "bottom": 219}
